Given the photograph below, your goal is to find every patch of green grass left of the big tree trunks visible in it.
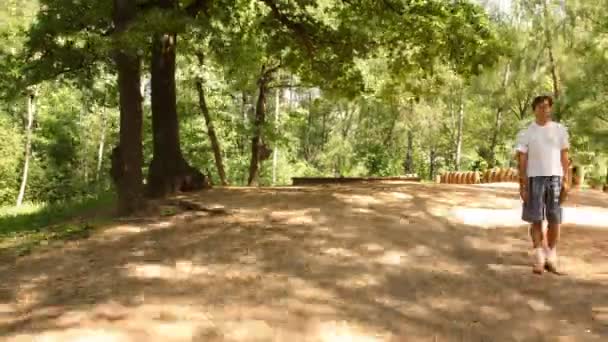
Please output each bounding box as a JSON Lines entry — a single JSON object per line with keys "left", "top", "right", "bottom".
{"left": 0, "top": 193, "right": 115, "bottom": 255}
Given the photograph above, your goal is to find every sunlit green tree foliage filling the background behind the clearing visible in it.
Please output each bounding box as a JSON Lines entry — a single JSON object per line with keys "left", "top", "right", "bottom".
{"left": 0, "top": 0, "right": 608, "bottom": 215}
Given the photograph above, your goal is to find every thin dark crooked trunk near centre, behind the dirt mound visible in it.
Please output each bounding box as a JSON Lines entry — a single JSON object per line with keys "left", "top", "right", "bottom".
{"left": 247, "top": 66, "right": 278, "bottom": 186}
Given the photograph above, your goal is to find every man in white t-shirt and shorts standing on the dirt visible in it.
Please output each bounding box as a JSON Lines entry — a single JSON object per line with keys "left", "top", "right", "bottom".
{"left": 516, "top": 96, "right": 570, "bottom": 274}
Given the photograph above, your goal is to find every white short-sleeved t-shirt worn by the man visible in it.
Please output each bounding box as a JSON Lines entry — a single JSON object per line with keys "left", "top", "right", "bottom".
{"left": 516, "top": 121, "right": 570, "bottom": 177}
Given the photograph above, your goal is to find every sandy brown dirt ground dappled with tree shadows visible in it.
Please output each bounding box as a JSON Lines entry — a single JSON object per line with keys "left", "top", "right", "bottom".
{"left": 0, "top": 183, "right": 608, "bottom": 342}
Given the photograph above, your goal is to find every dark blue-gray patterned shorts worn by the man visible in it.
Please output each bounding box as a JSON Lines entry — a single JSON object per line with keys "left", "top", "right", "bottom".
{"left": 522, "top": 176, "right": 562, "bottom": 224}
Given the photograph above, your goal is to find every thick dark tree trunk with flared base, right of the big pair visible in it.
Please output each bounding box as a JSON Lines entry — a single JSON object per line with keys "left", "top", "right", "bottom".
{"left": 147, "top": 27, "right": 209, "bottom": 197}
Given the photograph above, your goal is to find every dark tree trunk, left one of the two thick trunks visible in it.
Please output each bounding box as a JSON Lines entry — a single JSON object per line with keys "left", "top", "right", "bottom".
{"left": 111, "top": 0, "right": 144, "bottom": 214}
